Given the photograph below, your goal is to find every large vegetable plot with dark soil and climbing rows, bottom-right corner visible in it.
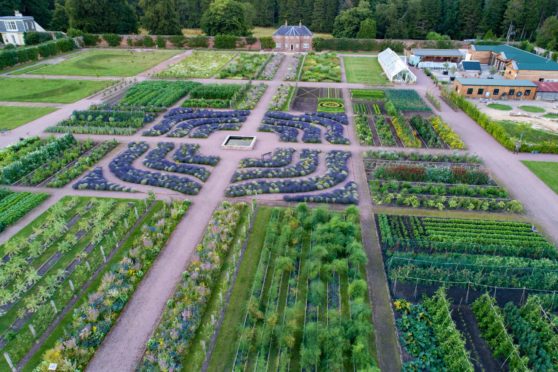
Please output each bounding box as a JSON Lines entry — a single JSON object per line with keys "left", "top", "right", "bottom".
{"left": 382, "top": 215, "right": 558, "bottom": 371}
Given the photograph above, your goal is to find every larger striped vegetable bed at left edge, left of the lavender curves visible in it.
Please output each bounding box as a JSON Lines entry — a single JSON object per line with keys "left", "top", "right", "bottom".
{"left": 0, "top": 134, "right": 117, "bottom": 187}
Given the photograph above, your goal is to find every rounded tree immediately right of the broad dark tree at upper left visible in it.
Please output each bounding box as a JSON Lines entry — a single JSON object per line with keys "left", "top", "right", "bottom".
{"left": 140, "top": 0, "right": 182, "bottom": 35}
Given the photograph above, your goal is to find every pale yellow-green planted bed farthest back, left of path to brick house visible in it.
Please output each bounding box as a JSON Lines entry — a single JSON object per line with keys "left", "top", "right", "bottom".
{"left": 157, "top": 51, "right": 284, "bottom": 80}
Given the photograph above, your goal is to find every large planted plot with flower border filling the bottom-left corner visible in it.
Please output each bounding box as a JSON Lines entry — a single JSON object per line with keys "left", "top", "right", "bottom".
{"left": 0, "top": 197, "right": 188, "bottom": 370}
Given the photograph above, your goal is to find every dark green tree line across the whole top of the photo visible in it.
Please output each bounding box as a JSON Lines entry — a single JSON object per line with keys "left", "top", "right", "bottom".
{"left": 0, "top": 0, "right": 558, "bottom": 49}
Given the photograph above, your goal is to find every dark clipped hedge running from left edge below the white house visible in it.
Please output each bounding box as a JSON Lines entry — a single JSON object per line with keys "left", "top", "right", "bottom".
{"left": 0, "top": 38, "right": 76, "bottom": 69}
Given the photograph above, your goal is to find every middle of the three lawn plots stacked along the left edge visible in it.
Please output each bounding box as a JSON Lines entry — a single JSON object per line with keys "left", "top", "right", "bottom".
{"left": 0, "top": 78, "right": 114, "bottom": 103}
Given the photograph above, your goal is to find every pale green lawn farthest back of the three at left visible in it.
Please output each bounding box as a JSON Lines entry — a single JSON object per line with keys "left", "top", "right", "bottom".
{"left": 15, "top": 50, "right": 179, "bottom": 76}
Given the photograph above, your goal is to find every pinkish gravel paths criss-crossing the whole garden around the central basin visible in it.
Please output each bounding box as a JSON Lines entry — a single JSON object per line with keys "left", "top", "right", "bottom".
{"left": 0, "top": 51, "right": 558, "bottom": 371}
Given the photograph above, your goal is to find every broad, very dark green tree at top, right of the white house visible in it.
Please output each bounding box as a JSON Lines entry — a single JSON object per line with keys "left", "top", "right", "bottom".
{"left": 66, "top": 0, "right": 137, "bottom": 34}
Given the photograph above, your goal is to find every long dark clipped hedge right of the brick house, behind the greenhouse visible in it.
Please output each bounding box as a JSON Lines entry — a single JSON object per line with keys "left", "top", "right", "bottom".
{"left": 312, "top": 37, "right": 405, "bottom": 53}
